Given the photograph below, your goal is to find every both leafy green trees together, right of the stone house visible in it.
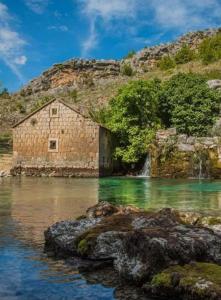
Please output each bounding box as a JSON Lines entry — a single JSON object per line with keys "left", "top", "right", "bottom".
{"left": 101, "top": 73, "right": 221, "bottom": 163}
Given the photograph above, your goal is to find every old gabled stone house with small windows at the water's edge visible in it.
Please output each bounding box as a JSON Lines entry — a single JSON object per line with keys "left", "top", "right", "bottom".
{"left": 12, "top": 100, "right": 112, "bottom": 177}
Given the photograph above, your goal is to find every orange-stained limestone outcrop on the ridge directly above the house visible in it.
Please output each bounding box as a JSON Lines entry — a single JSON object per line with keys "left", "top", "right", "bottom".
{"left": 21, "top": 59, "right": 120, "bottom": 96}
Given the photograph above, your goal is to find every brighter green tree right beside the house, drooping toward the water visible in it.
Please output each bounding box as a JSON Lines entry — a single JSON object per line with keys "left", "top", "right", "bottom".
{"left": 105, "top": 80, "right": 160, "bottom": 163}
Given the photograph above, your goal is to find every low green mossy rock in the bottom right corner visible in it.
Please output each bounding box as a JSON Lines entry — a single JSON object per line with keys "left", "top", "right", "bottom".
{"left": 151, "top": 263, "right": 221, "bottom": 299}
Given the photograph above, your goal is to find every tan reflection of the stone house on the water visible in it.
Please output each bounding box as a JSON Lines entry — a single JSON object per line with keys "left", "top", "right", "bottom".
{"left": 10, "top": 178, "right": 98, "bottom": 244}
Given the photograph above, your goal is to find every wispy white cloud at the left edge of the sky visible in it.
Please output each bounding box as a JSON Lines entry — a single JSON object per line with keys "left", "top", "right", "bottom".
{"left": 0, "top": 2, "right": 27, "bottom": 82}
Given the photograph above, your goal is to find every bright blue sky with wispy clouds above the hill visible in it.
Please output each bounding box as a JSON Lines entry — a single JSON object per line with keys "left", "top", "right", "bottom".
{"left": 0, "top": 0, "right": 221, "bottom": 91}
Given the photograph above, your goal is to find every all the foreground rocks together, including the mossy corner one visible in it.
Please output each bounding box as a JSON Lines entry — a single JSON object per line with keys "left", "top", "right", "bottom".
{"left": 45, "top": 202, "right": 221, "bottom": 299}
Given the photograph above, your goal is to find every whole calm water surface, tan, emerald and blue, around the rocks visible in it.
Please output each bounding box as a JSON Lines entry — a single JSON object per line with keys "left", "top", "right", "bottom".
{"left": 0, "top": 178, "right": 221, "bottom": 300}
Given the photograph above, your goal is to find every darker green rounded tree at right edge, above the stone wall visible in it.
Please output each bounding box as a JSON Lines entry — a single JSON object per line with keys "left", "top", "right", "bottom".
{"left": 159, "top": 73, "right": 221, "bottom": 136}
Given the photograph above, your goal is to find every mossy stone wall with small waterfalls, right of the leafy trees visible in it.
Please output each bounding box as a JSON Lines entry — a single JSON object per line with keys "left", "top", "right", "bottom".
{"left": 150, "top": 129, "right": 221, "bottom": 178}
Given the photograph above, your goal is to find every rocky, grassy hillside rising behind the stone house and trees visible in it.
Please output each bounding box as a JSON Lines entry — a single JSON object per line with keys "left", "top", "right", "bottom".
{"left": 0, "top": 29, "right": 221, "bottom": 137}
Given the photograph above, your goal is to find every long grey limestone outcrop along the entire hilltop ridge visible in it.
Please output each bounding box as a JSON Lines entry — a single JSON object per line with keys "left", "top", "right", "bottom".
{"left": 20, "top": 29, "right": 221, "bottom": 96}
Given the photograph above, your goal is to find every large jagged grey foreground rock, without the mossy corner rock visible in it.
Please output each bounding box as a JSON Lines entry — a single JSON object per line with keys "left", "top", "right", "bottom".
{"left": 45, "top": 202, "right": 221, "bottom": 299}
